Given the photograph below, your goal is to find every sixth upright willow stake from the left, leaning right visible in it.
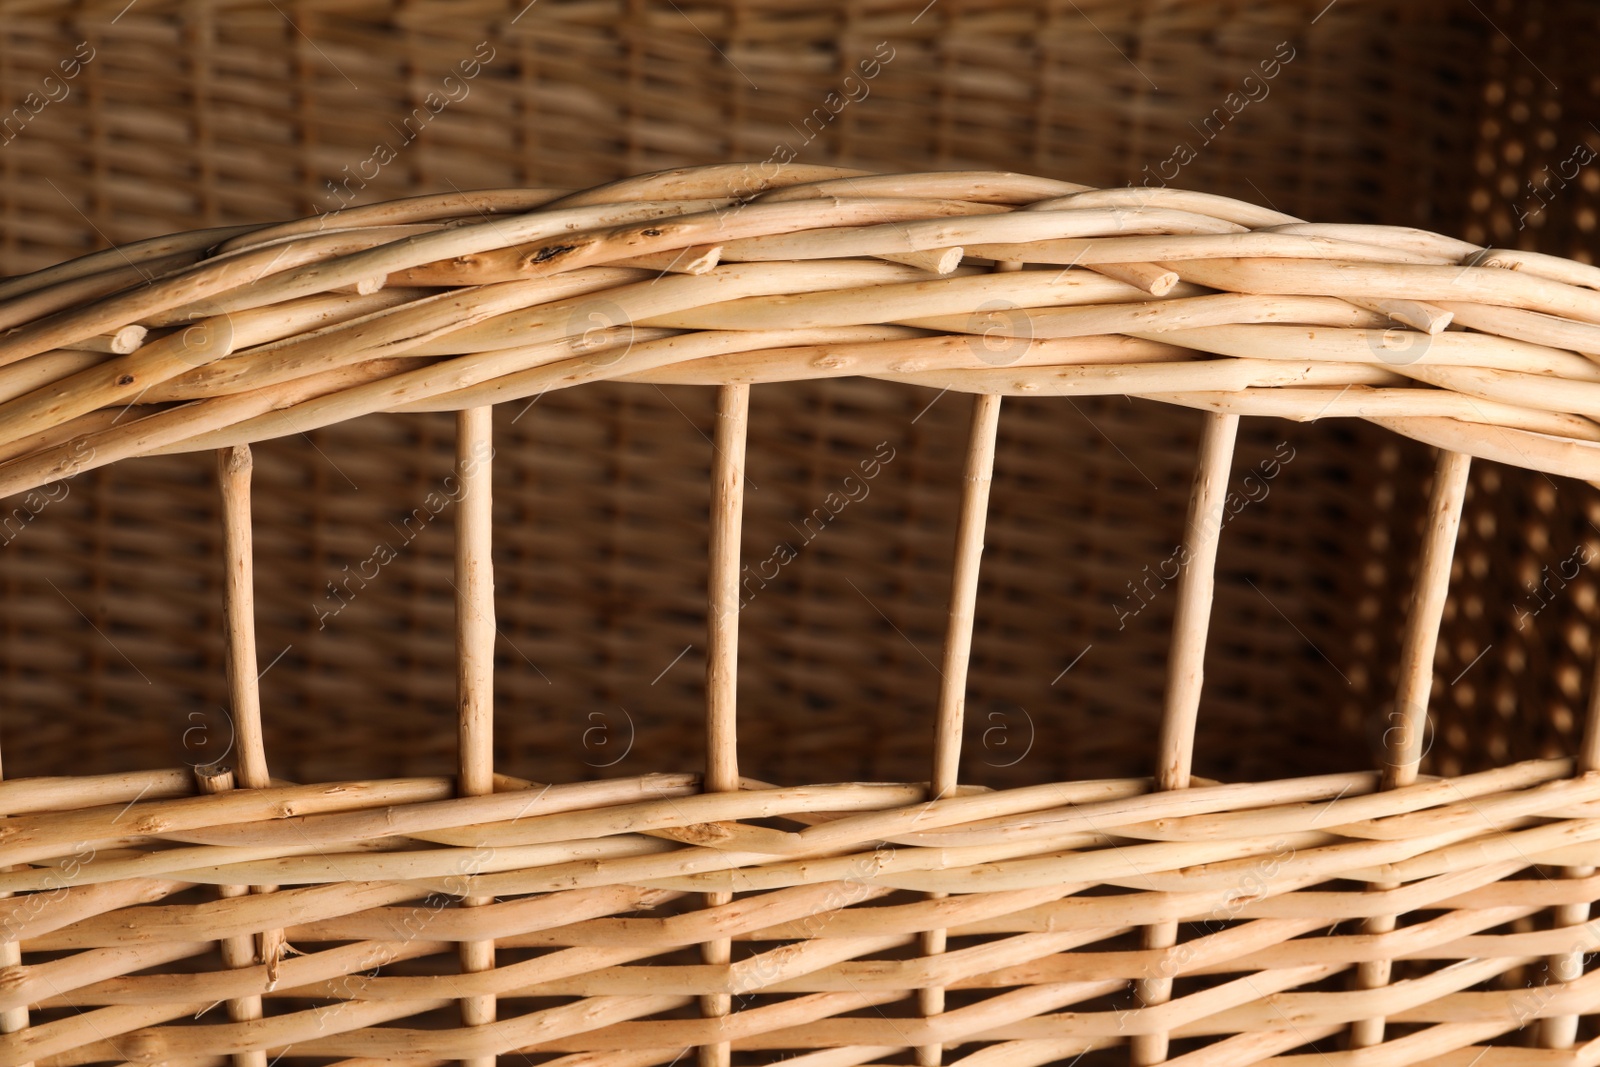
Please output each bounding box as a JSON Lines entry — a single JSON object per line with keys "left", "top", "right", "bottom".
{"left": 1350, "top": 451, "right": 1472, "bottom": 1048}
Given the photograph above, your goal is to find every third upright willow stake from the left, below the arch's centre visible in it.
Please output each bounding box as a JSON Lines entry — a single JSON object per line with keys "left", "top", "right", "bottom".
{"left": 699, "top": 386, "right": 750, "bottom": 1067}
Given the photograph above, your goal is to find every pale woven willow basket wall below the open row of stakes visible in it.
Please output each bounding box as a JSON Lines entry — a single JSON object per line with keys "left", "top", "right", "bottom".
{"left": 0, "top": 761, "right": 1600, "bottom": 1064}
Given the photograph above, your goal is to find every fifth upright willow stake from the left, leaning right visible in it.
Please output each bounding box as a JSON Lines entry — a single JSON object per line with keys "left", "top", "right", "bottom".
{"left": 1128, "top": 414, "right": 1238, "bottom": 1067}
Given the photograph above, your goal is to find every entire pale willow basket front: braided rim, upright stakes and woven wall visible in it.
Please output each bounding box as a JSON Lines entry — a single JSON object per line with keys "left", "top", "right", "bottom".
{"left": 0, "top": 166, "right": 1600, "bottom": 1067}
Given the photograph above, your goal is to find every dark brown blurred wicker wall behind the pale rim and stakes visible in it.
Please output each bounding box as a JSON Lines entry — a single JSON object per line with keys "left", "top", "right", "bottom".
{"left": 0, "top": 0, "right": 1600, "bottom": 785}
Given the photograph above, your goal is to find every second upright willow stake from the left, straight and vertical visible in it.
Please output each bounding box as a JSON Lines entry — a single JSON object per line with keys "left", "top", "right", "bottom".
{"left": 456, "top": 406, "right": 496, "bottom": 1067}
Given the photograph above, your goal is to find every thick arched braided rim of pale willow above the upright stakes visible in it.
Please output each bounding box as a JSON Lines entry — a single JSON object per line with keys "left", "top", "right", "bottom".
{"left": 0, "top": 166, "right": 1600, "bottom": 494}
